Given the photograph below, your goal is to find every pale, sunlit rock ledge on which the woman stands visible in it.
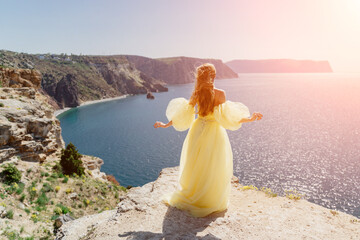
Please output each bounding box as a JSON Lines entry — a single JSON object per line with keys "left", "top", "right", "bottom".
{"left": 57, "top": 167, "right": 360, "bottom": 239}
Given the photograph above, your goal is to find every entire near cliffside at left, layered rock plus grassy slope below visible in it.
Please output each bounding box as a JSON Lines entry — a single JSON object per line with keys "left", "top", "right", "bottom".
{"left": 0, "top": 86, "right": 127, "bottom": 239}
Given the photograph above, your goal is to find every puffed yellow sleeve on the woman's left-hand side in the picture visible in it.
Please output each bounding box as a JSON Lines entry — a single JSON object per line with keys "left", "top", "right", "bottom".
{"left": 166, "top": 98, "right": 195, "bottom": 131}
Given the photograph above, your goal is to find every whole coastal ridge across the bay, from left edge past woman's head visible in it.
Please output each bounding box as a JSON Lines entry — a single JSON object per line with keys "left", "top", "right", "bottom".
{"left": 0, "top": 50, "right": 237, "bottom": 109}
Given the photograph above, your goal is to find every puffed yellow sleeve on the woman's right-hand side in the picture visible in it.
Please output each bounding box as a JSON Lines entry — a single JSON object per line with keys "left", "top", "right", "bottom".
{"left": 214, "top": 101, "right": 250, "bottom": 131}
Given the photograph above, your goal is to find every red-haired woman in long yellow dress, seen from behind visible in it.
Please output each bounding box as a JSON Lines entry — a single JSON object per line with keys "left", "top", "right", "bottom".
{"left": 154, "top": 63, "right": 262, "bottom": 217}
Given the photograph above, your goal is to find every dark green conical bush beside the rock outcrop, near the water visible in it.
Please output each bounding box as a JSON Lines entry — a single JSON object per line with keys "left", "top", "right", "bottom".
{"left": 60, "top": 142, "right": 85, "bottom": 176}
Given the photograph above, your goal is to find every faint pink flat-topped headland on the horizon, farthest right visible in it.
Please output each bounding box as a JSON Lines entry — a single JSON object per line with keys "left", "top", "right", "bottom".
{"left": 226, "top": 59, "right": 333, "bottom": 73}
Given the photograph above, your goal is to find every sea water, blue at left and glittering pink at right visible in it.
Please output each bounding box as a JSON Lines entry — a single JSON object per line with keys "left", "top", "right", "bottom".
{"left": 58, "top": 74, "right": 360, "bottom": 217}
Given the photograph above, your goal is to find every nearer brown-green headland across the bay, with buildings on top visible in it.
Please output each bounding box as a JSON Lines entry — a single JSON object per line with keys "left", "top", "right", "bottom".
{"left": 0, "top": 51, "right": 167, "bottom": 108}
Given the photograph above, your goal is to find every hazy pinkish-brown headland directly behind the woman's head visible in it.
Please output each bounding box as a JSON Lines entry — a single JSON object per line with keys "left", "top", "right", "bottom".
{"left": 125, "top": 56, "right": 237, "bottom": 84}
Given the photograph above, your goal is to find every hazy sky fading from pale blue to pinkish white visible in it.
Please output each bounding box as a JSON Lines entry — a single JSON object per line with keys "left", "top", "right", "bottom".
{"left": 0, "top": 0, "right": 360, "bottom": 72}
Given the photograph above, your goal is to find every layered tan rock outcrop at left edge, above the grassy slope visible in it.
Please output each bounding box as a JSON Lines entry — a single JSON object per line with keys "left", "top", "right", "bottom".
{"left": 0, "top": 87, "right": 65, "bottom": 162}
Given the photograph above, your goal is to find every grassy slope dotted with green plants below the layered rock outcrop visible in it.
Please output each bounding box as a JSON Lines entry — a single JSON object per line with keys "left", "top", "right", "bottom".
{"left": 0, "top": 152, "right": 127, "bottom": 239}
